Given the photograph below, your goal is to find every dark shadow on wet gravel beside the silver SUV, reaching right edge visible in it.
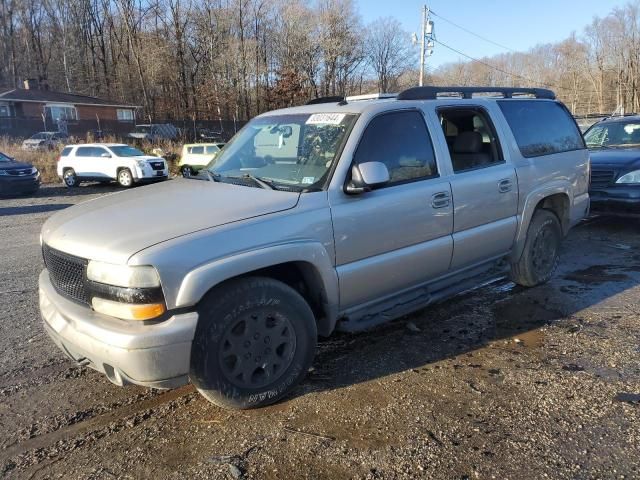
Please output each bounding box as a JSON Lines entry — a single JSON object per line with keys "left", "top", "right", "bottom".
{"left": 293, "top": 218, "right": 640, "bottom": 396}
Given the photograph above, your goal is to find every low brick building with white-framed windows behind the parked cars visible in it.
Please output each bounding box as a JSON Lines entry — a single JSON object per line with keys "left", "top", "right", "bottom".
{"left": 0, "top": 80, "right": 138, "bottom": 137}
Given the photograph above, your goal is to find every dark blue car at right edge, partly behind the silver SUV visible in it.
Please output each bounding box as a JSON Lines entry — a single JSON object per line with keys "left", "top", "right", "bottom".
{"left": 584, "top": 115, "right": 640, "bottom": 215}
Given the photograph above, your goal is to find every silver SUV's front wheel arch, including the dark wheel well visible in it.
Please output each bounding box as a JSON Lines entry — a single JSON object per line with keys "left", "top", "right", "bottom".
{"left": 176, "top": 242, "right": 339, "bottom": 336}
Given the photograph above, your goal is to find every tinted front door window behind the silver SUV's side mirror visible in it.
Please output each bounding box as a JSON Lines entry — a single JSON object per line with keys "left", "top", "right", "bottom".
{"left": 354, "top": 111, "right": 438, "bottom": 184}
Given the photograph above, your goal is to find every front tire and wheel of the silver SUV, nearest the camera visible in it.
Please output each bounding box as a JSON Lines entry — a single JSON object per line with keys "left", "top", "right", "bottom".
{"left": 189, "top": 277, "right": 317, "bottom": 409}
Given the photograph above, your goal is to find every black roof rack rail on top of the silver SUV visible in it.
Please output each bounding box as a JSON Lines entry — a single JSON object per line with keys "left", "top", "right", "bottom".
{"left": 397, "top": 87, "right": 556, "bottom": 100}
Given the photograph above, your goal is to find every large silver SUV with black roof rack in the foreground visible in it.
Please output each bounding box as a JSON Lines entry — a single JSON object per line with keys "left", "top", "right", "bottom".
{"left": 40, "top": 87, "right": 589, "bottom": 408}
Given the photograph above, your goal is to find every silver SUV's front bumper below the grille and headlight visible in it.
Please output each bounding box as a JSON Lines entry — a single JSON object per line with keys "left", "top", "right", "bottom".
{"left": 39, "top": 270, "right": 198, "bottom": 388}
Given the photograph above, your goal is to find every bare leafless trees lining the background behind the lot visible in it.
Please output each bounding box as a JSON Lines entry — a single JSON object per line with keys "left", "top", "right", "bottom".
{"left": 0, "top": 0, "right": 640, "bottom": 119}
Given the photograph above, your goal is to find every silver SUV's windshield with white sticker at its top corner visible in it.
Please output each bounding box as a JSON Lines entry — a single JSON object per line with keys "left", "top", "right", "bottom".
{"left": 207, "top": 113, "right": 356, "bottom": 190}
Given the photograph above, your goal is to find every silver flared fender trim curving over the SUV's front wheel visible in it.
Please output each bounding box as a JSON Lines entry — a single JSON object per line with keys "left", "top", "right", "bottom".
{"left": 170, "top": 241, "right": 340, "bottom": 335}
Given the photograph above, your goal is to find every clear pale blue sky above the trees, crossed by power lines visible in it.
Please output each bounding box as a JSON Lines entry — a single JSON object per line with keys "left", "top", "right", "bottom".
{"left": 356, "top": 0, "right": 628, "bottom": 69}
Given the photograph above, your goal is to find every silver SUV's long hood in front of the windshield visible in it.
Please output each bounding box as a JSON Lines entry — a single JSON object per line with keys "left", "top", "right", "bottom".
{"left": 42, "top": 179, "right": 300, "bottom": 264}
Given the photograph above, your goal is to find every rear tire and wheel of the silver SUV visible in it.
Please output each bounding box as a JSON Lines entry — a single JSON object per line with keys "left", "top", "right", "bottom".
{"left": 511, "top": 209, "right": 562, "bottom": 287}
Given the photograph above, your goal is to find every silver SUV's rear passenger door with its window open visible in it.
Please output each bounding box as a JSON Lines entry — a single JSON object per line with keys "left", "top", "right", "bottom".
{"left": 437, "top": 105, "right": 518, "bottom": 271}
